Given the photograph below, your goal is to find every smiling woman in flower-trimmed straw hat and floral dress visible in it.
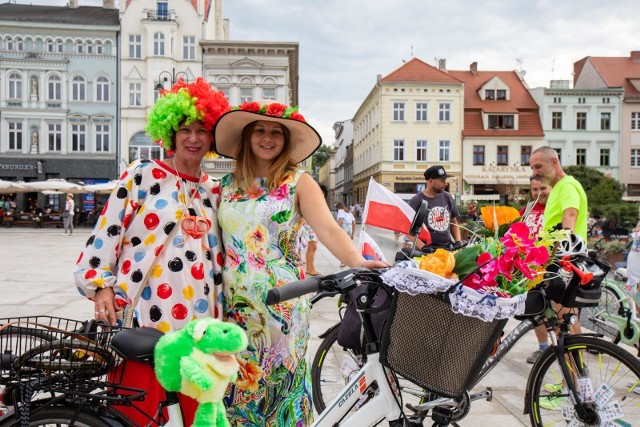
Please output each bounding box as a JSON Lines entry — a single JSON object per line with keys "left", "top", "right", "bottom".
{"left": 214, "top": 102, "right": 385, "bottom": 427}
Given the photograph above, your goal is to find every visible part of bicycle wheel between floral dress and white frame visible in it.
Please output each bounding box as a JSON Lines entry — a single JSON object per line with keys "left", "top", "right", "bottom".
{"left": 311, "top": 327, "right": 366, "bottom": 413}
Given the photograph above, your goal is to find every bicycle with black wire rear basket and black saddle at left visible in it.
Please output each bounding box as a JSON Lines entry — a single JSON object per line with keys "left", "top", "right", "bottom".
{"left": 0, "top": 316, "right": 183, "bottom": 427}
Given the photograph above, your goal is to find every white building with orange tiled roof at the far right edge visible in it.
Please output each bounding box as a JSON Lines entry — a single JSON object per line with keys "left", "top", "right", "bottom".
{"left": 573, "top": 51, "right": 640, "bottom": 201}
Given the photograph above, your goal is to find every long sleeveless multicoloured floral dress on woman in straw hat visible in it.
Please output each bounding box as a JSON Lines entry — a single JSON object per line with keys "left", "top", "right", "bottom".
{"left": 218, "top": 170, "right": 313, "bottom": 427}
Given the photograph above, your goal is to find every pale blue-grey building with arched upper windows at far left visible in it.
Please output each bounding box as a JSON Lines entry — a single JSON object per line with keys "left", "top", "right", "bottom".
{"left": 0, "top": 0, "right": 120, "bottom": 210}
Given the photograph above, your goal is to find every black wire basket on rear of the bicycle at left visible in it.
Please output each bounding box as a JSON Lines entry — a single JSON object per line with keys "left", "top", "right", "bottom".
{"left": 0, "top": 316, "right": 120, "bottom": 385}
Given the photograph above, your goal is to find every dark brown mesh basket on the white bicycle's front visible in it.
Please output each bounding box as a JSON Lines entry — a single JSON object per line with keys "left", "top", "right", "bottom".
{"left": 380, "top": 292, "right": 507, "bottom": 397}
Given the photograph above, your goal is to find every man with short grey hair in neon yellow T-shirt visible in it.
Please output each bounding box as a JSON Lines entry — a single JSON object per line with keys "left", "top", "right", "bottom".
{"left": 529, "top": 146, "right": 589, "bottom": 242}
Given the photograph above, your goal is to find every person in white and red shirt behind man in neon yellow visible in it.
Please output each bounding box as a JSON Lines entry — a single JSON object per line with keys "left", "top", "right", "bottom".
{"left": 520, "top": 175, "right": 551, "bottom": 364}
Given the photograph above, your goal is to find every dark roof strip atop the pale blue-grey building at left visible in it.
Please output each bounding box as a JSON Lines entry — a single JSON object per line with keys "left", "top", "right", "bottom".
{"left": 0, "top": 3, "right": 120, "bottom": 26}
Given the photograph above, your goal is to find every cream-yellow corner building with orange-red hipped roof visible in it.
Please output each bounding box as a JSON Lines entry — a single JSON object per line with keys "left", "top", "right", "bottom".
{"left": 353, "top": 58, "right": 464, "bottom": 206}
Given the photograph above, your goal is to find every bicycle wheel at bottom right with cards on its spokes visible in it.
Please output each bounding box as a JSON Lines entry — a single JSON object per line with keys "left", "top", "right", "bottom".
{"left": 525, "top": 335, "right": 640, "bottom": 426}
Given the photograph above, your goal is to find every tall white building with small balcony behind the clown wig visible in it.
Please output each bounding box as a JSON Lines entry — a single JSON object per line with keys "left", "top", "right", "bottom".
{"left": 118, "top": 0, "right": 228, "bottom": 176}
